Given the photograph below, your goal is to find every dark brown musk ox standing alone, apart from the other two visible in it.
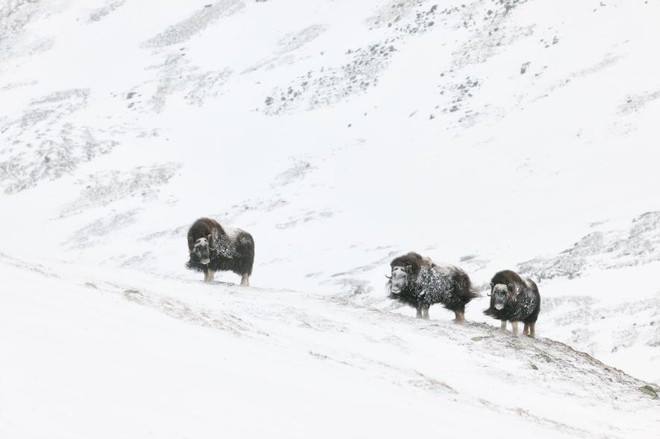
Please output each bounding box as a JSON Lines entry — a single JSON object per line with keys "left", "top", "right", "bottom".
{"left": 186, "top": 218, "right": 254, "bottom": 286}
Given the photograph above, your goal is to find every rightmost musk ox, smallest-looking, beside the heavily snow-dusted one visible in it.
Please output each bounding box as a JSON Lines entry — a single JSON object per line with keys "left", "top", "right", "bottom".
{"left": 484, "top": 270, "right": 541, "bottom": 337}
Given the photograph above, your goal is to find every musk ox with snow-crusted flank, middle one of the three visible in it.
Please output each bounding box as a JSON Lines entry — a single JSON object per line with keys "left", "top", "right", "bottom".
{"left": 387, "top": 252, "right": 479, "bottom": 323}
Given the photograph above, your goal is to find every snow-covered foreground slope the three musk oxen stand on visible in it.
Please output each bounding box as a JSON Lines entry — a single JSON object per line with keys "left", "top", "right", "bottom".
{"left": 0, "top": 256, "right": 660, "bottom": 438}
